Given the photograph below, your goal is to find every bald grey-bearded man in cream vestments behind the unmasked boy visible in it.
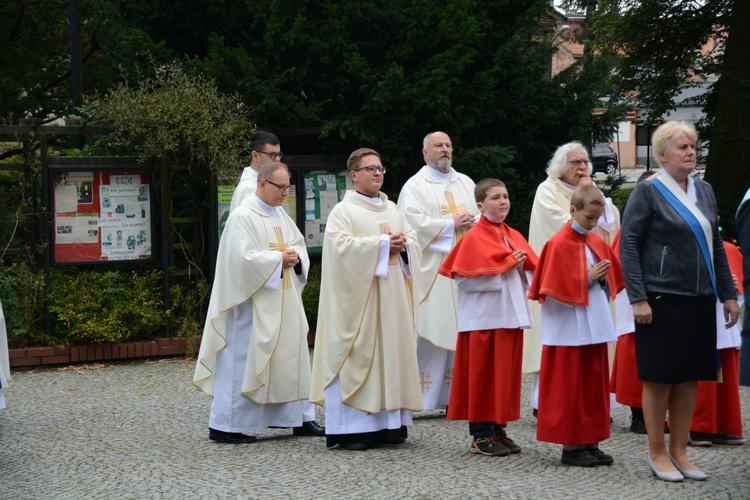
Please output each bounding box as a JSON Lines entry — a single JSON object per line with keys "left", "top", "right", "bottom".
{"left": 398, "top": 132, "right": 478, "bottom": 410}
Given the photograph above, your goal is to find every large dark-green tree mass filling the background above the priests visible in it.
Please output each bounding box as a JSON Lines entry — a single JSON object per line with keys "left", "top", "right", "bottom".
{"left": 0, "top": 0, "right": 610, "bottom": 189}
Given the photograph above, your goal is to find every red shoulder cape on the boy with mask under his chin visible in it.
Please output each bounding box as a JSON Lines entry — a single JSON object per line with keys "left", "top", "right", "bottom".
{"left": 529, "top": 222, "right": 625, "bottom": 306}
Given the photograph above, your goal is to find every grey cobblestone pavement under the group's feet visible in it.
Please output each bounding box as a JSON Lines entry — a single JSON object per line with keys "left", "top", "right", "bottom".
{"left": 0, "top": 359, "right": 750, "bottom": 499}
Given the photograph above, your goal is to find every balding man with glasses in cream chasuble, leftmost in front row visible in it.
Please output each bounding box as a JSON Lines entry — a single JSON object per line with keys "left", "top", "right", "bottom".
{"left": 193, "top": 162, "right": 325, "bottom": 444}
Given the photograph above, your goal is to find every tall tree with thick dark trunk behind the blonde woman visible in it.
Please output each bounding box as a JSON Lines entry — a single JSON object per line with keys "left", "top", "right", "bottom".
{"left": 593, "top": 0, "right": 750, "bottom": 229}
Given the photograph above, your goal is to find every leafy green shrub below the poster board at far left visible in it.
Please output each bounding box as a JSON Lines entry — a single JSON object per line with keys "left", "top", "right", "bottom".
{"left": 50, "top": 268, "right": 167, "bottom": 345}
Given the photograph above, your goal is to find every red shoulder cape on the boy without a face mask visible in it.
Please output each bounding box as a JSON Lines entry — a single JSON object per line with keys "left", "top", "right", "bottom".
{"left": 438, "top": 216, "right": 538, "bottom": 278}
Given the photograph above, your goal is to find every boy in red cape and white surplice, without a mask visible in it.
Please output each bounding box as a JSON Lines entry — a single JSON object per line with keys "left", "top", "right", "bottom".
{"left": 439, "top": 179, "right": 537, "bottom": 456}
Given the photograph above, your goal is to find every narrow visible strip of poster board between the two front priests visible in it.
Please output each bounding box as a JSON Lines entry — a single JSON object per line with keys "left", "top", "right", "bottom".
{"left": 302, "top": 170, "right": 354, "bottom": 253}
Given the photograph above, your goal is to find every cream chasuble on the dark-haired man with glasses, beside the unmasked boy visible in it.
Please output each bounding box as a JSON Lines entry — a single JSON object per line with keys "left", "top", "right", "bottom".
{"left": 310, "top": 191, "right": 422, "bottom": 414}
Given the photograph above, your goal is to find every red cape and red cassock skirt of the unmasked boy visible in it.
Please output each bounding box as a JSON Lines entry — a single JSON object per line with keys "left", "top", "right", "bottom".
{"left": 439, "top": 217, "right": 538, "bottom": 425}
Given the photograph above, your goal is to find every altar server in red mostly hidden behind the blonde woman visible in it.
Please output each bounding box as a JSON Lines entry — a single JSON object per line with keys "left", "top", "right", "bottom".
{"left": 688, "top": 241, "right": 747, "bottom": 446}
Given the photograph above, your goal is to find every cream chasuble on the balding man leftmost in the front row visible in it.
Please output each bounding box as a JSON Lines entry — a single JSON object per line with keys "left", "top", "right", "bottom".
{"left": 193, "top": 197, "right": 310, "bottom": 404}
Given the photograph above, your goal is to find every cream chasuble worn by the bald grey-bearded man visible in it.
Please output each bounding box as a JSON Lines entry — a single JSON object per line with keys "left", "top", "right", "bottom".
{"left": 398, "top": 165, "right": 478, "bottom": 351}
